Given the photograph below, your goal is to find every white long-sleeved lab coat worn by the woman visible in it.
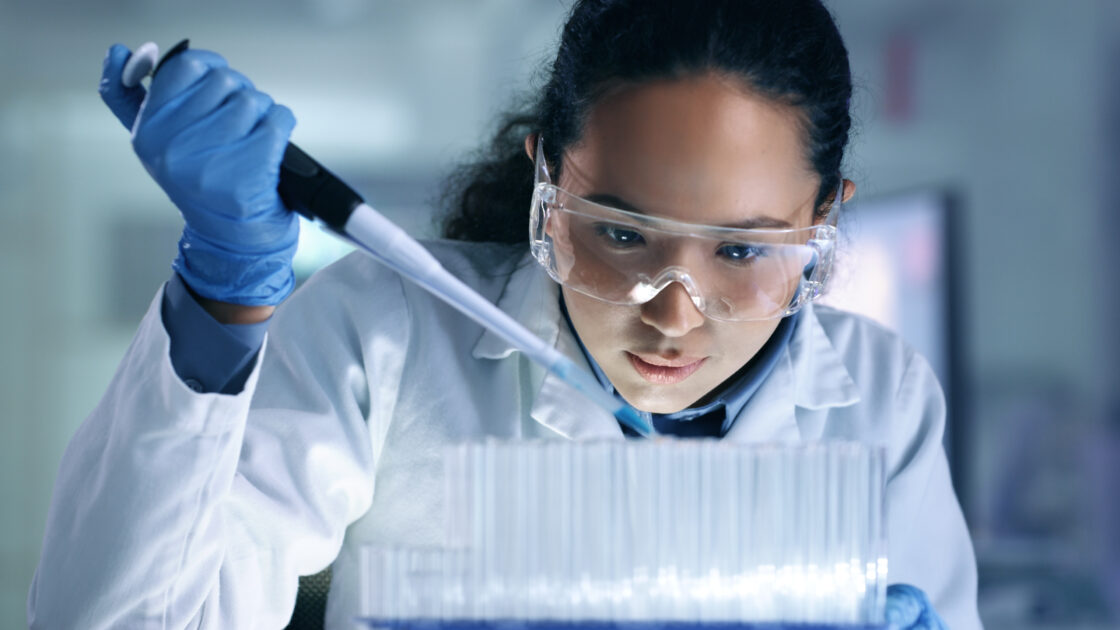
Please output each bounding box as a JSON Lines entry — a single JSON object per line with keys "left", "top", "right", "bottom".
{"left": 28, "top": 237, "right": 980, "bottom": 630}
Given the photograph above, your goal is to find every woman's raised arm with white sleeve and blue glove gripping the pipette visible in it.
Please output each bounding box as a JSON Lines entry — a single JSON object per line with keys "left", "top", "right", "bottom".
{"left": 28, "top": 41, "right": 389, "bottom": 628}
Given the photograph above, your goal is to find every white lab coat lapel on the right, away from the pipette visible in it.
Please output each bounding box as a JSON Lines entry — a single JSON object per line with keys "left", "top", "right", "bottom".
{"left": 725, "top": 305, "right": 859, "bottom": 443}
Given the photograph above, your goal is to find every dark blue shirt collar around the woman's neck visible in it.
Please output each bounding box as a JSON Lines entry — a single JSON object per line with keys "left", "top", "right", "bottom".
{"left": 560, "top": 296, "right": 800, "bottom": 437}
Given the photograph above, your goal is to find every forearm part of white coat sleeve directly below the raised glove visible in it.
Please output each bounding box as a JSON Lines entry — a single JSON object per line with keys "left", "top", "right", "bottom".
{"left": 28, "top": 282, "right": 266, "bottom": 628}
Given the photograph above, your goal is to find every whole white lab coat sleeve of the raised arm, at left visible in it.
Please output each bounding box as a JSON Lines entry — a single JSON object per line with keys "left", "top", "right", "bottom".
{"left": 28, "top": 263, "right": 408, "bottom": 629}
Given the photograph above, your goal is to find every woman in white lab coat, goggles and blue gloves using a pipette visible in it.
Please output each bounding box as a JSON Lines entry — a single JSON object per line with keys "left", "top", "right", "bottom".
{"left": 28, "top": 0, "right": 979, "bottom": 629}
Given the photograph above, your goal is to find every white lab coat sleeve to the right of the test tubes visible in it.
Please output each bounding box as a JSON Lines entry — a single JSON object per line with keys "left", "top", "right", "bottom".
{"left": 886, "top": 352, "right": 981, "bottom": 630}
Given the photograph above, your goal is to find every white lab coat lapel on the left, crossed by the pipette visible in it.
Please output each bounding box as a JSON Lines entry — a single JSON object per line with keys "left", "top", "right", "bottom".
{"left": 474, "top": 254, "right": 624, "bottom": 439}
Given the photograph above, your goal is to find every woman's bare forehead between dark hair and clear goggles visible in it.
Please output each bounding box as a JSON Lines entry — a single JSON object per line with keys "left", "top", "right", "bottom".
{"left": 564, "top": 74, "right": 819, "bottom": 223}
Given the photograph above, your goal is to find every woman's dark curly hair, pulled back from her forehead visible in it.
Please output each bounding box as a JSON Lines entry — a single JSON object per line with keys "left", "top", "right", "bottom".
{"left": 444, "top": 0, "right": 851, "bottom": 243}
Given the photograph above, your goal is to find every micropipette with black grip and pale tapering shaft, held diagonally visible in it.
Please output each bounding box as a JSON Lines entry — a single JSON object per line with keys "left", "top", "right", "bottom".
{"left": 122, "top": 39, "right": 653, "bottom": 436}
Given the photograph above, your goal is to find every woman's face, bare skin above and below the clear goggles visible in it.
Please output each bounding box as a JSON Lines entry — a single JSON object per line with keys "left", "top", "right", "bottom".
{"left": 558, "top": 75, "right": 824, "bottom": 414}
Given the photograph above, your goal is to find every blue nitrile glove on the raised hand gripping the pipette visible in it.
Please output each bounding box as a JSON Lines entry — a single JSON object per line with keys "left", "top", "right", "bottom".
{"left": 99, "top": 44, "right": 299, "bottom": 306}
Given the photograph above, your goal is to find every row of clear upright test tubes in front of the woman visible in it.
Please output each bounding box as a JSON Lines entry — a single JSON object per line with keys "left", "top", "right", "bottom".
{"left": 362, "top": 441, "right": 887, "bottom": 626}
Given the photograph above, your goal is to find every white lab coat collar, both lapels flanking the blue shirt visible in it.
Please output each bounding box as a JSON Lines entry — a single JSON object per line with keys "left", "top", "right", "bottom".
{"left": 474, "top": 253, "right": 859, "bottom": 443}
